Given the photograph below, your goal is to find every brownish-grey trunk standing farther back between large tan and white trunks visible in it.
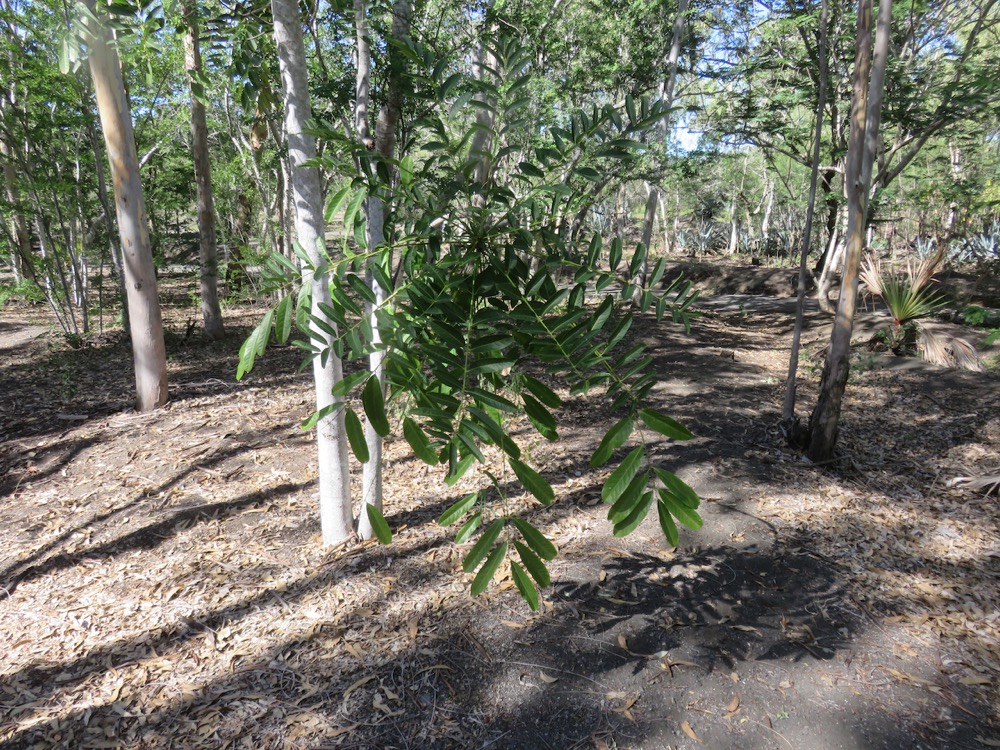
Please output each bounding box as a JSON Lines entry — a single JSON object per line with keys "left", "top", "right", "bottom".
{"left": 181, "top": 0, "right": 225, "bottom": 341}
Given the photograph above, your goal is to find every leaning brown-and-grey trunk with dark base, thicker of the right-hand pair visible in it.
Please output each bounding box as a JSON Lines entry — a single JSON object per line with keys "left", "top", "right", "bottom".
{"left": 809, "top": 0, "right": 892, "bottom": 462}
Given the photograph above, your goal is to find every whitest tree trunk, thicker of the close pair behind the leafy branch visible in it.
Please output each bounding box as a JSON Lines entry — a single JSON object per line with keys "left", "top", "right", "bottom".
{"left": 271, "top": 0, "right": 352, "bottom": 545}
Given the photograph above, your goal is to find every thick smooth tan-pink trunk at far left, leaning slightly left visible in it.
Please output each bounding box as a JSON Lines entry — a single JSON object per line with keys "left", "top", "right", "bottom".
{"left": 88, "top": 2, "right": 167, "bottom": 411}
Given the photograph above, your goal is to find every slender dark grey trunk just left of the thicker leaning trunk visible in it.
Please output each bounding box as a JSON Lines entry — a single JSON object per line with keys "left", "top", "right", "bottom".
{"left": 781, "top": 0, "right": 830, "bottom": 432}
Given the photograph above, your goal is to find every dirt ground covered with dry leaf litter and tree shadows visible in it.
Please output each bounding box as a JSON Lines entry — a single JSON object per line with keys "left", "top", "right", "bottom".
{"left": 0, "top": 270, "right": 1000, "bottom": 750}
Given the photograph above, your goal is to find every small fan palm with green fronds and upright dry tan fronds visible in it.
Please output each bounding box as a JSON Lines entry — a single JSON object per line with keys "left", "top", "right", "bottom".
{"left": 860, "top": 246, "right": 945, "bottom": 354}
